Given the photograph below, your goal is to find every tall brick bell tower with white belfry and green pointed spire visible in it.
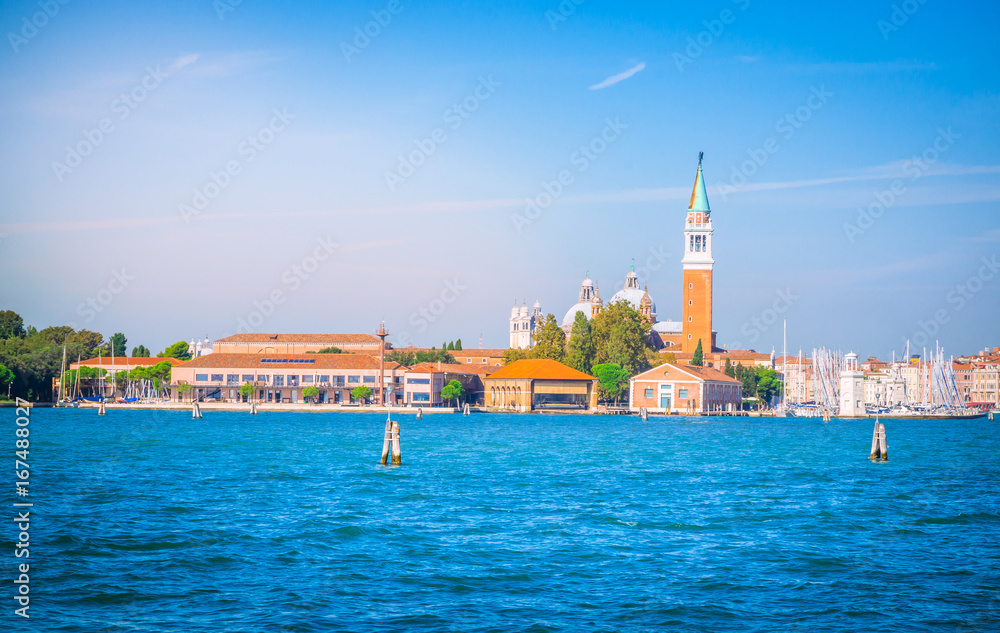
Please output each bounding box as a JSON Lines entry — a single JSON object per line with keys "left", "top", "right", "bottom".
{"left": 681, "top": 152, "right": 715, "bottom": 354}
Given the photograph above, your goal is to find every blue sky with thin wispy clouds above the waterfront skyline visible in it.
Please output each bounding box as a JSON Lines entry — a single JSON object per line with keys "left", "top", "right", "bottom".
{"left": 0, "top": 0, "right": 1000, "bottom": 357}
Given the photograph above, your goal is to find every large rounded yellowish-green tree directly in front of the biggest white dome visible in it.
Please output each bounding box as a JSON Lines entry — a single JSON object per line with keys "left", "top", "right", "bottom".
{"left": 590, "top": 301, "right": 652, "bottom": 376}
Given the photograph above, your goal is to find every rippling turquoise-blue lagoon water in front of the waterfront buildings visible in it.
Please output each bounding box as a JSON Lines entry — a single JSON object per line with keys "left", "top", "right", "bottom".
{"left": 7, "top": 409, "right": 1000, "bottom": 632}
